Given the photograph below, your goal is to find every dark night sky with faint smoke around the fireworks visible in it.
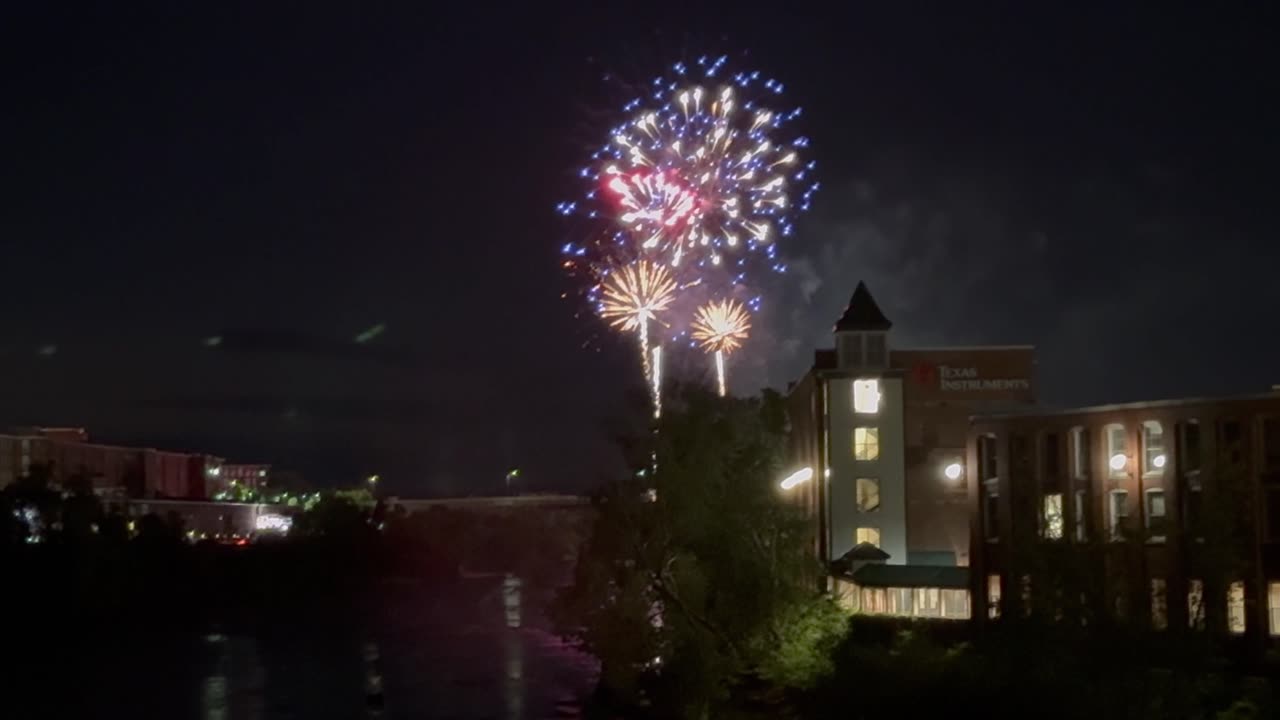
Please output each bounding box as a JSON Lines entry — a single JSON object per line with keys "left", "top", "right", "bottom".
{"left": 0, "top": 3, "right": 1280, "bottom": 495}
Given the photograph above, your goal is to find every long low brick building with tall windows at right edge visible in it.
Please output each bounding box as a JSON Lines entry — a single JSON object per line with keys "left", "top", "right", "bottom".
{"left": 968, "top": 392, "right": 1280, "bottom": 639}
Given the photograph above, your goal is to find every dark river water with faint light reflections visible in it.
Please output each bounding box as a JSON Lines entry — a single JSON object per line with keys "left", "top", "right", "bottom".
{"left": 44, "top": 575, "right": 596, "bottom": 720}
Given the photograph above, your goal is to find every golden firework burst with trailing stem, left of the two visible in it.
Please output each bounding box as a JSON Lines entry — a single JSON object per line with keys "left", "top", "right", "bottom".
{"left": 599, "top": 260, "right": 676, "bottom": 414}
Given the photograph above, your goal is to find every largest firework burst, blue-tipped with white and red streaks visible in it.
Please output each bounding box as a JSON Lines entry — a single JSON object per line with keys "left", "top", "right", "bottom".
{"left": 558, "top": 58, "right": 818, "bottom": 289}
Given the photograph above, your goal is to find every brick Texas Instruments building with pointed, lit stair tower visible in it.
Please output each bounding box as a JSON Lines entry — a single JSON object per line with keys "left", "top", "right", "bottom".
{"left": 785, "top": 283, "right": 1034, "bottom": 618}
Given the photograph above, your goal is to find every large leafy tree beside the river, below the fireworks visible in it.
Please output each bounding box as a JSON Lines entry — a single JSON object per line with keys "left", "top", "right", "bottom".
{"left": 556, "top": 387, "right": 846, "bottom": 717}
